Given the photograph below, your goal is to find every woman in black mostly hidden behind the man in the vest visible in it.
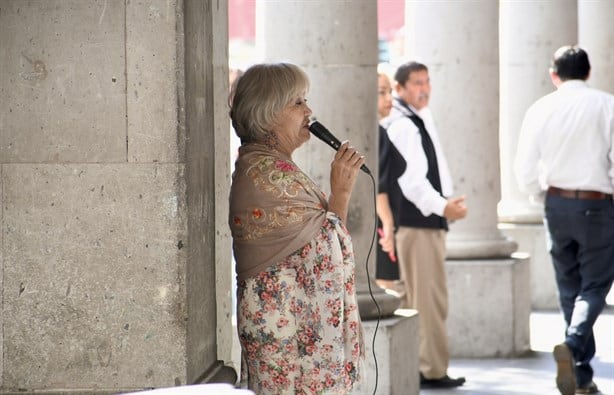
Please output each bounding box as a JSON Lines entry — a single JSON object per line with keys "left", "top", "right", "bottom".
{"left": 375, "top": 73, "right": 402, "bottom": 295}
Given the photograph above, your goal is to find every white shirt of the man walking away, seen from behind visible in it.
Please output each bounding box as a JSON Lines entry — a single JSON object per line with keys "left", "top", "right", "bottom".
{"left": 514, "top": 80, "right": 614, "bottom": 195}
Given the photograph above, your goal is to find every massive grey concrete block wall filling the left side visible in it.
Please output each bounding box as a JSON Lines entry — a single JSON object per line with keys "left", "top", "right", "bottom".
{"left": 0, "top": 0, "right": 230, "bottom": 393}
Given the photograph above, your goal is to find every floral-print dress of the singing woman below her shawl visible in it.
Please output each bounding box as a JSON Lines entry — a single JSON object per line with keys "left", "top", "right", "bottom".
{"left": 237, "top": 212, "right": 364, "bottom": 395}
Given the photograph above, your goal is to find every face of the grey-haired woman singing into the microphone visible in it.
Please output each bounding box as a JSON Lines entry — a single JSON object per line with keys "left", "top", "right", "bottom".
{"left": 272, "top": 94, "right": 312, "bottom": 155}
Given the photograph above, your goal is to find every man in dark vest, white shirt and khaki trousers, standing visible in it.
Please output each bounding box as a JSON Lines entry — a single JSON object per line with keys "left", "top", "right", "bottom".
{"left": 378, "top": 62, "right": 467, "bottom": 388}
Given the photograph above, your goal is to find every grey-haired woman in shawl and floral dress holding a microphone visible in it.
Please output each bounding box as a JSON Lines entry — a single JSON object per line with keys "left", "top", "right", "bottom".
{"left": 229, "top": 63, "right": 365, "bottom": 395}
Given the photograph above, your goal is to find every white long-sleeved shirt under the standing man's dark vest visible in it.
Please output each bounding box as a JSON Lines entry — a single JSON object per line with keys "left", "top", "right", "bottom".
{"left": 381, "top": 101, "right": 453, "bottom": 217}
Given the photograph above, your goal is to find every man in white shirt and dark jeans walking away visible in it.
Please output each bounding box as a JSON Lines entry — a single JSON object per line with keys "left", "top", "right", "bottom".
{"left": 515, "top": 46, "right": 614, "bottom": 395}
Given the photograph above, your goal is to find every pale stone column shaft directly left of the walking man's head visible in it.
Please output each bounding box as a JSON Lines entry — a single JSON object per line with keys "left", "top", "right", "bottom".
{"left": 499, "top": 0, "right": 577, "bottom": 223}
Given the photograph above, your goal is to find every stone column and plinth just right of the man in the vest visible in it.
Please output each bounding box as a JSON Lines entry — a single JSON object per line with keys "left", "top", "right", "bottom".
{"left": 405, "top": 0, "right": 530, "bottom": 356}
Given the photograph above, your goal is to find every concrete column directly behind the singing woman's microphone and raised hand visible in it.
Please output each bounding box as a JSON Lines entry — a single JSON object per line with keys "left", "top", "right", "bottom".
{"left": 256, "top": 0, "right": 399, "bottom": 319}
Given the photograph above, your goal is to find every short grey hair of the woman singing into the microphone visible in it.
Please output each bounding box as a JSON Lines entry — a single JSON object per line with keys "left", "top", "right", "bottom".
{"left": 229, "top": 63, "right": 309, "bottom": 144}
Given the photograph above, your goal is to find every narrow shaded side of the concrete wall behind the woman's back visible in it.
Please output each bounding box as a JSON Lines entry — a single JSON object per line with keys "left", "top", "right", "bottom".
{"left": 183, "top": 0, "right": 240, "bottom": 383}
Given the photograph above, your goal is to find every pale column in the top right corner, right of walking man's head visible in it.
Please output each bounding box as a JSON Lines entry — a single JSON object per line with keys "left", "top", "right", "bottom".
{"left": 578, "top": 0, "right": 614, "bottom": 93}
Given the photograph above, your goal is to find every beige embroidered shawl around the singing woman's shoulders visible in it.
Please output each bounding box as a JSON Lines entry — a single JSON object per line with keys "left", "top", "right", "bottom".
{"left": 229, "top": 144, "right": 328, "bottom": 281}
